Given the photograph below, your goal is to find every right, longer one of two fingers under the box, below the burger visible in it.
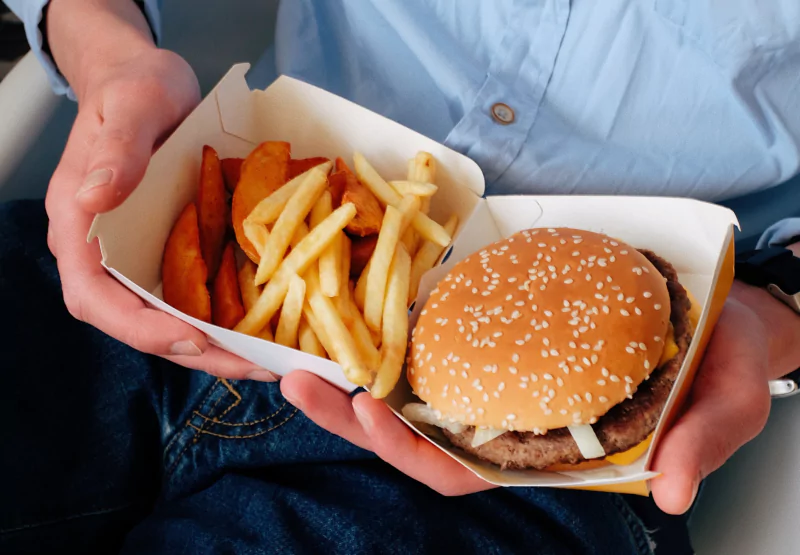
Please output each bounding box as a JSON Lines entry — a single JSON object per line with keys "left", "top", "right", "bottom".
{"left": 353, "top": 394, "right": 496, "bottom": 495}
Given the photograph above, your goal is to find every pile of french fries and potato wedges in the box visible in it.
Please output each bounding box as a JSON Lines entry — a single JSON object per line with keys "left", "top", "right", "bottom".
{"left": 162, "top": 141, "right": 458, "bottom": 398}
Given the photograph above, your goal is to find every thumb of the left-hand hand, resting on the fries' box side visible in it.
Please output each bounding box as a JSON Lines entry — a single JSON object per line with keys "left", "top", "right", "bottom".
{"left": 76, "top": 99, "right": 178, "bottom": 213}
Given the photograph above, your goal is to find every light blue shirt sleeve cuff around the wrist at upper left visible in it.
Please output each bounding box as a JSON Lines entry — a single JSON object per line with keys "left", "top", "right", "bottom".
{"left": 4, "top": 0, "right": 161, "bottom": 100}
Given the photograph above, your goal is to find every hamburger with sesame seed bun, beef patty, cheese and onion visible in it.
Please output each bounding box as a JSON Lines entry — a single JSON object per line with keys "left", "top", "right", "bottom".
{"left": 403, "top": 228, "right": 699, "bottom": 470}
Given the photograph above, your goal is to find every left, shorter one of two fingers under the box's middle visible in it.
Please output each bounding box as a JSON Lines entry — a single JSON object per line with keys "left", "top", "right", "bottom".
{"left": 281, "top": 370, "right": 371, "bottom": 450}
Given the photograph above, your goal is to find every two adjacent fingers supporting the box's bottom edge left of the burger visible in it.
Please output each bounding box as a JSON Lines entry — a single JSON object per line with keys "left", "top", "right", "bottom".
{"left": 281, "top": 371, "right": 495, "bottom": 495}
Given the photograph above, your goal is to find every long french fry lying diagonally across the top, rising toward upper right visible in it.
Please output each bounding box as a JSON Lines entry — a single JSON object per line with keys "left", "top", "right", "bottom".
{"left": 235, "top": 204, "right": 356, "bottom": 334}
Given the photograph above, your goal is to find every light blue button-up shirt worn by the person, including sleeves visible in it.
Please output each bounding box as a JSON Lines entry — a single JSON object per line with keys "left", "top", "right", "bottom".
{"left": 9, "top": 0, "right": 800, "bottom": 245}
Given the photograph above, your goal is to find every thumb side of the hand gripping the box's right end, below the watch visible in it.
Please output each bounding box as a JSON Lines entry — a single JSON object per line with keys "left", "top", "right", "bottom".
{"left": 652, "top": 276, "right": 800, "bottom": 514}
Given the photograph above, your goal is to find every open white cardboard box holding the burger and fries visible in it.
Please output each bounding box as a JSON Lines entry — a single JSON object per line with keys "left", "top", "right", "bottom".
{"left": 89, "top": 64, "right": 738, "bottom": 495}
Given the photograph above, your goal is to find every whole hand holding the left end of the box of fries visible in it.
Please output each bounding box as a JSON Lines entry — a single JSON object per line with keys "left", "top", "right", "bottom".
{"left": 46, "top": 47, "right": 273, "bottom": 381}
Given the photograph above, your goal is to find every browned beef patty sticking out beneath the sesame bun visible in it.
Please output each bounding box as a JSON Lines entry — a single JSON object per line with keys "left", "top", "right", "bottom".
{"left": 443, "top": 250, "right": 692, "bottom": 470}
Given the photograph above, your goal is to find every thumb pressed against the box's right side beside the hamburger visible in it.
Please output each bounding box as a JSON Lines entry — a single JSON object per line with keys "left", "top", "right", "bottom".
{"left": 652, "top": 308, "right": 770, "bottom": 514}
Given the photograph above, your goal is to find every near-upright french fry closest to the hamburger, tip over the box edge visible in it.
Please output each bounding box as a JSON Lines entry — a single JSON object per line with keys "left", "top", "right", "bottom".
{"left": 370, "top": 245, "right": 411, "bottom": 399}
